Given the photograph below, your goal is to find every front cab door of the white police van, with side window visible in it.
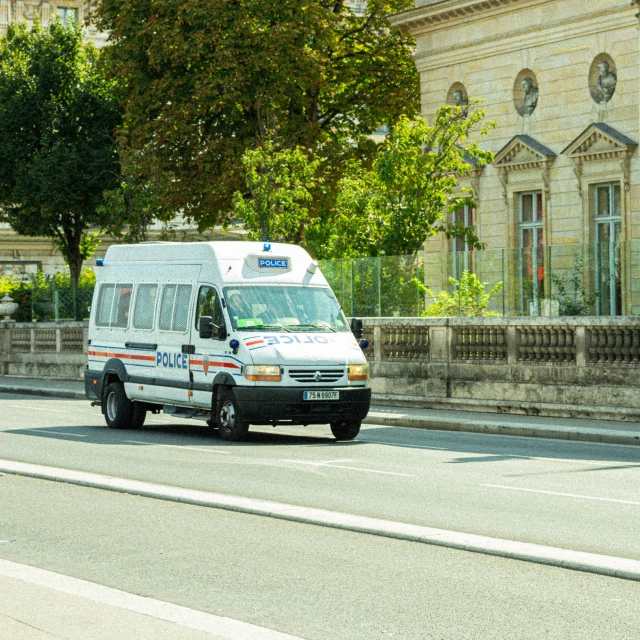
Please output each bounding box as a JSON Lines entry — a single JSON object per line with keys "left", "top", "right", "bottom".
{"left": 190, "top": 284, "right": 242, "bottom": 409}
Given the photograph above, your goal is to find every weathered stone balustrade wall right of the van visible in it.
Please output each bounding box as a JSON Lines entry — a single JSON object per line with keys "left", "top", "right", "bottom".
{"left": 364, "top": 318, "right": 640, "bottom": 420}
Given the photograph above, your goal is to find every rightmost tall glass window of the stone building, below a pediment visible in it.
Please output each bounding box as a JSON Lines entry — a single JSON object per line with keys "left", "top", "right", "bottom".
{"left": 595, "top": 182, "right": 622, "bottom": 316}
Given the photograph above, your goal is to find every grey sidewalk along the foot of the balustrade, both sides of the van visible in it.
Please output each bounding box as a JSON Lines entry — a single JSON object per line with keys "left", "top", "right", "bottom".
{"left": 0, "top": 377, "right": 640, "bottom": 445}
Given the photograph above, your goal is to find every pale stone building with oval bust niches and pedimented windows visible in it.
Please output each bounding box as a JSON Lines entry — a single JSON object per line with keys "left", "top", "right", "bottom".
{"left": 391, "top": 0, "right": 640, "bottom": 315}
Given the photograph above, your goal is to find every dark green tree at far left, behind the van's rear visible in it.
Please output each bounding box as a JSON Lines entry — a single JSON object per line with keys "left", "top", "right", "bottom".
{"left": 0, "top": 22, "right": 120, "bottom": 283}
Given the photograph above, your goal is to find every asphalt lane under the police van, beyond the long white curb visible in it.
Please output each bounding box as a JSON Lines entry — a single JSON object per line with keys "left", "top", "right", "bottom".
{"left": 0, "top": 395, "right": 640, "bottom": 559}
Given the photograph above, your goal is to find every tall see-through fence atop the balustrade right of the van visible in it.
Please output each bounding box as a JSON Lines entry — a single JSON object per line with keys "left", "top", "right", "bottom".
{"left": 320, "top": 240, "right": 640, "bottom": 317}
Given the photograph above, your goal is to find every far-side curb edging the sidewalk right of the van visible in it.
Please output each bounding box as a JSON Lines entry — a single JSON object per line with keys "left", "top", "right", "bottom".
{"left": 363, "top": 409, "right": 640, "bottom": 446}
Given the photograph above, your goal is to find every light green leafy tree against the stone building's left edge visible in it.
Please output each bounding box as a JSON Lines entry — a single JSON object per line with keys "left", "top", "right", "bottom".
{"left": 328, "top": 101, "right": 493, "bottom": 257}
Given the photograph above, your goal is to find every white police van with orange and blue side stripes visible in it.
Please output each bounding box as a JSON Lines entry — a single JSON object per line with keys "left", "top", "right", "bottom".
{"left": 85, "top": 242, "right": 371, "bottom": 440}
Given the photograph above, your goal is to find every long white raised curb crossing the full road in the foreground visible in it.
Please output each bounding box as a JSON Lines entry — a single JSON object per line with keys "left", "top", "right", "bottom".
{"left": 0, "top": 460, "right": 640, "bottom": 581}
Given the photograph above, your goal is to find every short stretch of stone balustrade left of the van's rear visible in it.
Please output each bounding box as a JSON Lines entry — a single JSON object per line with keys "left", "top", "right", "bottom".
{"left": 0, "top": 322, "right": 88, "bottom": 380}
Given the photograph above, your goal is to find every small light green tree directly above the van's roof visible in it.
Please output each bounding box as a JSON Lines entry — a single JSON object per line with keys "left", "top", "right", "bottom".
{"left": 233, "top": 136, "right": 321, "bottom": 243}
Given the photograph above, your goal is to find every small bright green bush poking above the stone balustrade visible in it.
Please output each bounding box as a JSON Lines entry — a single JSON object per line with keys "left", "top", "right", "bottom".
{"left": 422, "top": 270, "right": 503, "bottom": 317}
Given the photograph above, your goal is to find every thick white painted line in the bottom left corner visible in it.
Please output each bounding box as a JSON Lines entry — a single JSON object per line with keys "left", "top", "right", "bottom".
{"left": 0, "top": 560, "right": 300, "bottom": 640}
